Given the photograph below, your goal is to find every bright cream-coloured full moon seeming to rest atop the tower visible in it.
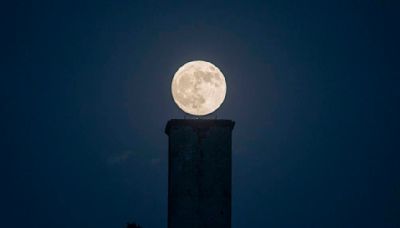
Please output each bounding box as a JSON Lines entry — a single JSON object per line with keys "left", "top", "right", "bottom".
{"left": 171, "top": 60, "right": 226, "bottom": 116}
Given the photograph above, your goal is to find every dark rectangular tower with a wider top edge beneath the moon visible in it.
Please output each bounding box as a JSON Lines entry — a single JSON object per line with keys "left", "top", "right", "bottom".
{"left": 165, "top": 119, "right": 234, "bottom": 228}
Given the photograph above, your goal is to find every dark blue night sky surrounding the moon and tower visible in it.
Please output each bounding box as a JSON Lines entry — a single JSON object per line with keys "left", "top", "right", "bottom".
{"left": 6, "top": 0, "right": 400, "bottom": 228}
